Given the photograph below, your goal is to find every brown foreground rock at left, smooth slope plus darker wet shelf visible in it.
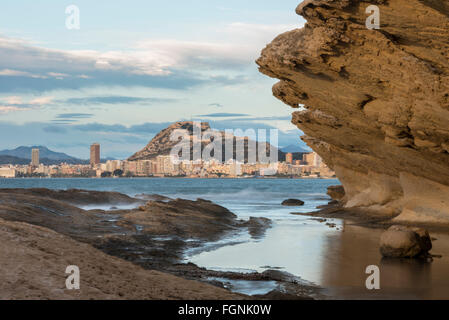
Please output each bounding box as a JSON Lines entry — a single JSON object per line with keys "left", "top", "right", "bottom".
{"left": 0, "top": 189, "right": 280, "bottom": 299}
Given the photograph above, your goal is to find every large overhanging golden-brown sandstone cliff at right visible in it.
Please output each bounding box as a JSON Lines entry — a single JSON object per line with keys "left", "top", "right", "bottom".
{"left": 257, "top": 0, "right": 449, "bottom": 223}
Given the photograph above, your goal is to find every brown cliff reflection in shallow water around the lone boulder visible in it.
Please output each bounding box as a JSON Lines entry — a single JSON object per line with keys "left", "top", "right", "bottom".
{"left": 321, "top": 222, "right": 449, "bottom": 299}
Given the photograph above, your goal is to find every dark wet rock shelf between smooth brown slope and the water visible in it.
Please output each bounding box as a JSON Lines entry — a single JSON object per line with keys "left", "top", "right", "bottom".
{"left": 0, "top": 189, "right": 319, "bottom": 299}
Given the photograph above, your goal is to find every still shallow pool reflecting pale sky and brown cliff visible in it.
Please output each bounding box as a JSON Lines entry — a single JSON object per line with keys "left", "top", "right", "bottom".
{"left": 190, "top": 217, "right": 449, "bottom": 299}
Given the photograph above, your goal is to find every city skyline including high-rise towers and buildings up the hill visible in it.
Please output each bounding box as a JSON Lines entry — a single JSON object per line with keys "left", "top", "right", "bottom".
{"left": 0, "top": 134, "right": 328, "bottom": 178}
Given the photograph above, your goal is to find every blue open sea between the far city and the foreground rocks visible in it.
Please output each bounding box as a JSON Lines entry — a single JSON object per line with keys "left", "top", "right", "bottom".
{"left": 0, "top": 178, "right": 338, "bottom": 219}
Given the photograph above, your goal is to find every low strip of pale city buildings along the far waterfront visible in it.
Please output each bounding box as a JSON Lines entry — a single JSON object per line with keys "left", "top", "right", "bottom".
{"left": 0, "top": 151, "right": 335, "bottom": 178}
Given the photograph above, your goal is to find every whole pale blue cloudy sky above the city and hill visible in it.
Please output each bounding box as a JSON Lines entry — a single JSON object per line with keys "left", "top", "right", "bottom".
{"left": 0, "top": 0, "right": 304, "bottom": 159}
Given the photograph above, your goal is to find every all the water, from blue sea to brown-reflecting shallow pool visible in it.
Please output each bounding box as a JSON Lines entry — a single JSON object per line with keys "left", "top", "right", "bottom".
{"left": 0, "top": 178, "right": 449, "bottom": 299}
